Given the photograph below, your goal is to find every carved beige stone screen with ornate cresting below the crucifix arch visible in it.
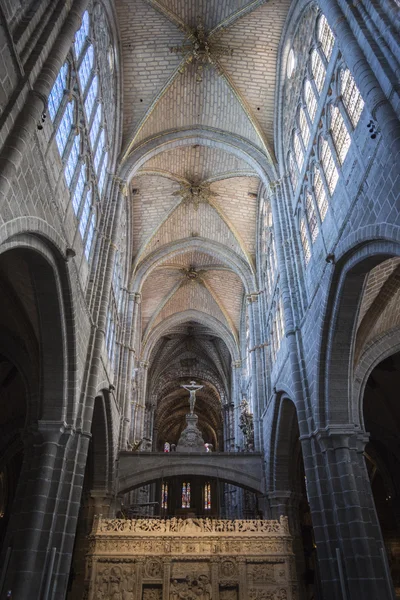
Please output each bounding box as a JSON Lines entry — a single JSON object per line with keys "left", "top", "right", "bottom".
{"left": 86, "top": 517, "right": 297, "bottom": 600}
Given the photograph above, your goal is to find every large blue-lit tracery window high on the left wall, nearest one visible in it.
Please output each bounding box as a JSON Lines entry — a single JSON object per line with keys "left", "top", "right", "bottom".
{"left": 48, "top": 11, "right": 110, "bottom": 259}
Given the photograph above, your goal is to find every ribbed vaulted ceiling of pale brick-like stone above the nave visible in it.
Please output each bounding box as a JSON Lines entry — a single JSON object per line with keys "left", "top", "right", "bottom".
{"left": 116, "top": 0, "right": 290, "bottom": 420}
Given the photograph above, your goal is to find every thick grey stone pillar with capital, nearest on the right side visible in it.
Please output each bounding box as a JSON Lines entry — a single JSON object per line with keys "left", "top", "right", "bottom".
{"left": 302, "top": 426, "right": 394, "bottom": 600}
